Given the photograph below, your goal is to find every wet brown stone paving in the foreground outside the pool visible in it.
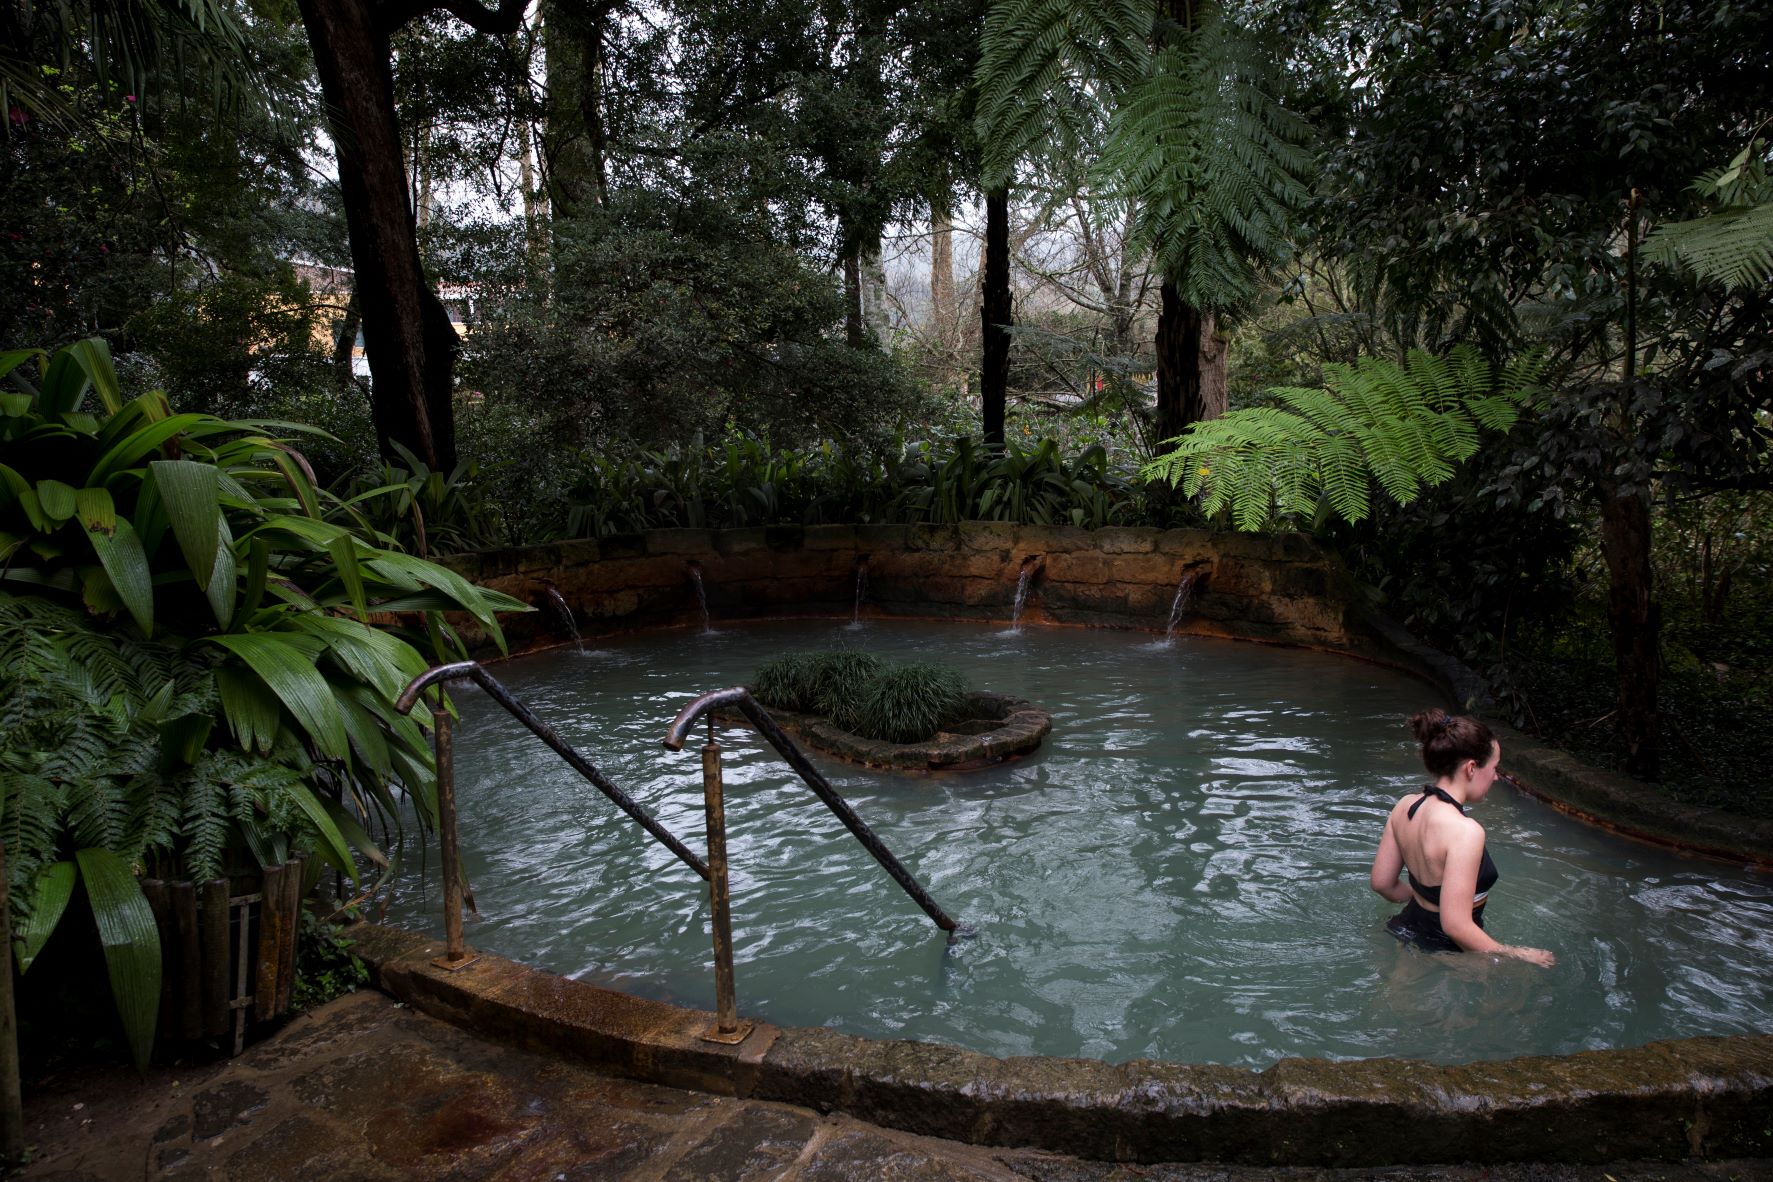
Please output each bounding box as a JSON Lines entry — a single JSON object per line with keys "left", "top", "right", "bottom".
{"left": 23, "top": 991, "right": 1773, "bottom": 1182}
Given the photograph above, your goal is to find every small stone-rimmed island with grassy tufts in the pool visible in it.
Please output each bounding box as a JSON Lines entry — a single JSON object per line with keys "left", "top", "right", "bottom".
{"left": 737, "top": 650, "right": 1053, "bottom": 771}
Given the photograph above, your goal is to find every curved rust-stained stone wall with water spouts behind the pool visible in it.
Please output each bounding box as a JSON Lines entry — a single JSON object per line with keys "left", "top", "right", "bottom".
{"left": 450, "top": 521, "right": 1390, "bottom": 657}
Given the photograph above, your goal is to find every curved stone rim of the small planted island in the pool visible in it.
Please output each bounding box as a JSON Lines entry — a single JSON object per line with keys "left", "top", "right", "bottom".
{"left": 720, "top": 689, "right": 1053, "bottom": 771}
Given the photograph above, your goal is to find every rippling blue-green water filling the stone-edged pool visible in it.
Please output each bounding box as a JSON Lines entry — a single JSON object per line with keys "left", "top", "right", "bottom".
{"left": 390, "top": 624, "right": 1773, "bottom": 1067}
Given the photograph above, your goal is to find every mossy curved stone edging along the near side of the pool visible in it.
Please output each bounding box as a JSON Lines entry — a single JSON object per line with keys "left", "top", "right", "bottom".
{"left": 351, "top": 923, "right": 1773, "bottom": 1166}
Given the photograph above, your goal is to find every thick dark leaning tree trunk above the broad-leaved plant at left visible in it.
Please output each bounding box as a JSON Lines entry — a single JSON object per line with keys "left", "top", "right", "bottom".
{"left": 298, "top": 0, "right": 456, "bottom": 470}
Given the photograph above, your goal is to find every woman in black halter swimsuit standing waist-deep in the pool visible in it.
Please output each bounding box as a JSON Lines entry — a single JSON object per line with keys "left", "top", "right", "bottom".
{"left": 1372, "top": 711, "right": 1557, "bottom": 966}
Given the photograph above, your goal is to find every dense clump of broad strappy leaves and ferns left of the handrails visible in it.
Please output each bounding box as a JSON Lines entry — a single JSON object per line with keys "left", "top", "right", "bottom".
{"left": 0, "top": 338, "right": 527, "bottom": 1063}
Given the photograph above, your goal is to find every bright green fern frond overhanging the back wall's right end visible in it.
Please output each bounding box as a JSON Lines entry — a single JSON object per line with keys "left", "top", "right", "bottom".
{"left": 1145, "top": 346, "right": 1541, "bottom": 530}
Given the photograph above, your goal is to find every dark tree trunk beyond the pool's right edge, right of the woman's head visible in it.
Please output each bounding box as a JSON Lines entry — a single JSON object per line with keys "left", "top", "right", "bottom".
{"left": 1601, "top": 489, "right": 1661, "bottom": 780}
